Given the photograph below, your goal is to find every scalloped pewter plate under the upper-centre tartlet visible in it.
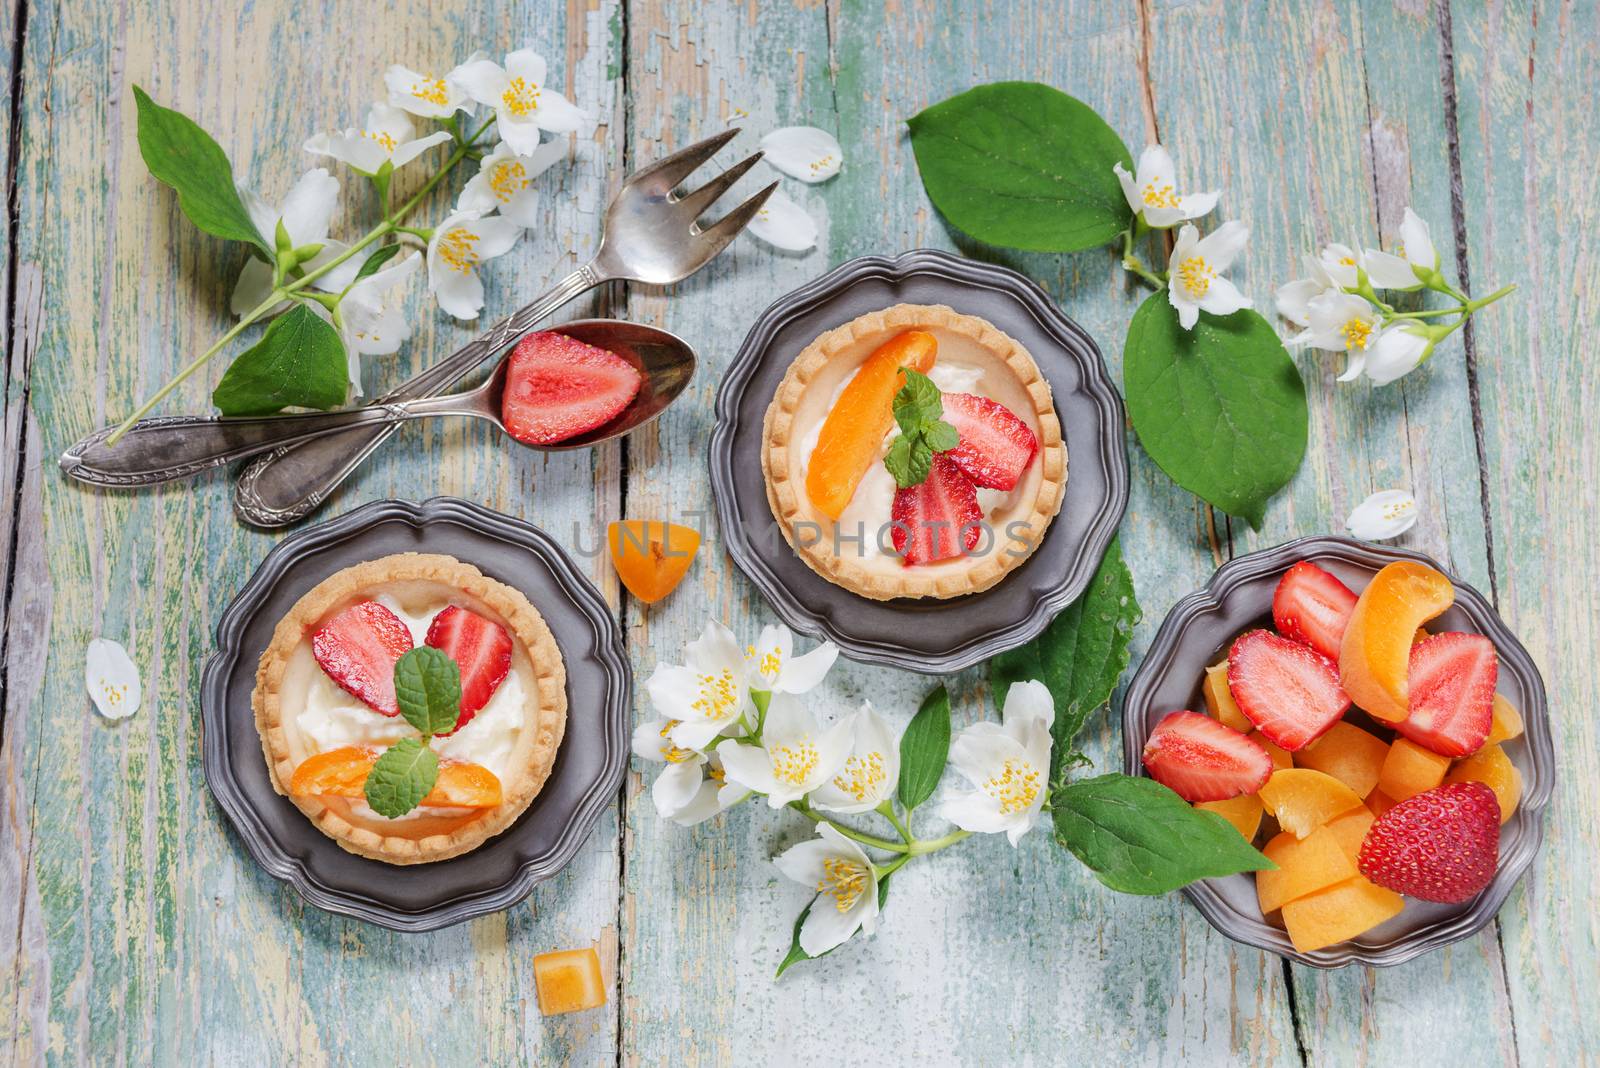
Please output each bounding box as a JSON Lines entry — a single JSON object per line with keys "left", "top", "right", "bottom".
{"left": 710, "top": 249, "right": 1128, "bottom": 675}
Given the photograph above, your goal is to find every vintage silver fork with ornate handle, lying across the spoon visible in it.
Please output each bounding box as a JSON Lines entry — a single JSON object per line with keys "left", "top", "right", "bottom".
{"left": 234, "top": 128, "right": 778, "bottom": 526}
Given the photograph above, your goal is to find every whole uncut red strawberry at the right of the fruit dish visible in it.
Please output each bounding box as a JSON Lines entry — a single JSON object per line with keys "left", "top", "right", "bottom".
{"left": 1357, "top": 782, "right": 1501, "bottom": 905}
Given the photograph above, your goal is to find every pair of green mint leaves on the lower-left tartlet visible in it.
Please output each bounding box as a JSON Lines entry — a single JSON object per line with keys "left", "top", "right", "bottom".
{"left": 362, "top": 646, "right": 461, "bottom": 820}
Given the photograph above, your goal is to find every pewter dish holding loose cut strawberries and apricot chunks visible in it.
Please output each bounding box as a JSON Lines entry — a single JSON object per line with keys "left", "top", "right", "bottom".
{"left": 1123, "top": 536, "right": 1555, "bottom": 967}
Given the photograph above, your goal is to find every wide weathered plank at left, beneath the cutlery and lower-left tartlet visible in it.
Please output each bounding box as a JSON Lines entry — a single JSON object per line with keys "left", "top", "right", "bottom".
{"left": 0, "top": 2, "right": 619, "bottom": 1063}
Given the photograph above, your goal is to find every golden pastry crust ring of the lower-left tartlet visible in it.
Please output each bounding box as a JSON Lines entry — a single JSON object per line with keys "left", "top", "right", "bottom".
{"left": 251, "top": 553, "right": 566, "bottom": 865}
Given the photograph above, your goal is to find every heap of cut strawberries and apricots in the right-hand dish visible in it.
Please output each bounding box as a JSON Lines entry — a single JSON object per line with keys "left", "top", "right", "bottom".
{"left": 1142, "top": 561, "right": 1523, "bottom": 953}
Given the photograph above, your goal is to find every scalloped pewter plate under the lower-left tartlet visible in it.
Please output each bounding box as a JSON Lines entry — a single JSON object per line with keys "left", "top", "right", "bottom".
{"left": 200, "top": 497, "right": 634, "bottom": 931}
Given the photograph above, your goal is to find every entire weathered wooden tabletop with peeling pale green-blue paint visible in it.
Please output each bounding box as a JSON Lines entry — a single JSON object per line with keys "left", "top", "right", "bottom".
{"left": 0, "top": 0, "right": 1600, "bottom": 1065}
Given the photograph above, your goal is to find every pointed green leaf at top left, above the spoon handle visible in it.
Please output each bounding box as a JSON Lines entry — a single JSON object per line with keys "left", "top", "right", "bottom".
{"left": 133, "top": 86, "right": 274, "bottom": 255}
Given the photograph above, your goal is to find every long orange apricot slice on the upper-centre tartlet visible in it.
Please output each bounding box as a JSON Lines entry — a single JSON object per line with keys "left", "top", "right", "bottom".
{"left": 805, "top": 329, "right": 939, "bottom": 520}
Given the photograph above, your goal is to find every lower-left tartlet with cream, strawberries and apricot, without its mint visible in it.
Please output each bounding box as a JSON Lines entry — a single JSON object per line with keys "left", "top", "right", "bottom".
{"left": 251, "top": 553, "right": 566, "bottom": 863}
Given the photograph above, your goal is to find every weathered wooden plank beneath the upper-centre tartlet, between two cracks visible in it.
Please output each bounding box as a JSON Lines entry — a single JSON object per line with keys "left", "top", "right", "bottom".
{"left": 611, "top": 3, "right": 1294, "bottom": 1063}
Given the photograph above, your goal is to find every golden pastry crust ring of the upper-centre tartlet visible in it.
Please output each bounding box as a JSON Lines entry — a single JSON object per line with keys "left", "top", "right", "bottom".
{"left": 762, "top": 304, "right": 1067, "bottom": 601}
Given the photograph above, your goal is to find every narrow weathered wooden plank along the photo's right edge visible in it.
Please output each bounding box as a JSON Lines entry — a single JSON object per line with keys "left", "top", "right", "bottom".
{"left": 1451, "top": 2, "right": 1600, "bottom": 1063}
